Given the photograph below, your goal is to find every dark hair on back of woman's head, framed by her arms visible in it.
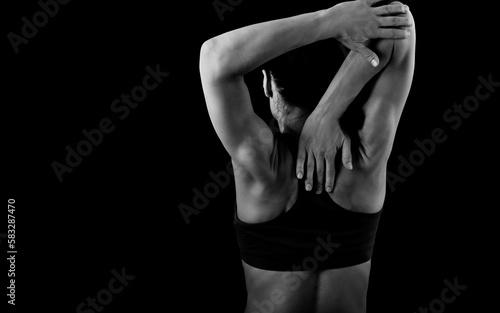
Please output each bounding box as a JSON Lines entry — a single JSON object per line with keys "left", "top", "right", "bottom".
{"left": 263, "top": 40, "right": 341, "bottom": 115}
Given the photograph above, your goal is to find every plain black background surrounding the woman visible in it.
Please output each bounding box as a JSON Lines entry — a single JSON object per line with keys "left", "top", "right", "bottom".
{"left": 0, "top": 0, "right": 500, "bottom": 312}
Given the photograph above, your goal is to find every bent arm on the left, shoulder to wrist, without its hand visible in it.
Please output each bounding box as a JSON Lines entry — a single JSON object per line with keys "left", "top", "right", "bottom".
{"left": 200, "top": 12, "right": 331, "bottom": 179}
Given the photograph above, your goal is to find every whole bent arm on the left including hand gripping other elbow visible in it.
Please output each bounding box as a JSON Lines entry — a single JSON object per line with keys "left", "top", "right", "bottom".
{"left": 200, "top": 0, "right": 408, "bottom": 179}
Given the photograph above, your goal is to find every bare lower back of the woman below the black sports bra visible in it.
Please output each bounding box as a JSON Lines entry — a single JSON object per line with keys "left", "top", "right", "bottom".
{"left": 243, "top": 261, "right": 371, "bottom": 313}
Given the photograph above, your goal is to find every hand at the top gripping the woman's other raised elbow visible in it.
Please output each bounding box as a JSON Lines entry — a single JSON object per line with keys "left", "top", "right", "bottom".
{"left": 327, "top": 0, "right": 412, "bottom": 67}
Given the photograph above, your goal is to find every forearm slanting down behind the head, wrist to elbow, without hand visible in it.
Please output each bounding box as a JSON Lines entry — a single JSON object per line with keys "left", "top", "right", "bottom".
{"left": 316, "top": 40, "right": 394, "bottom": 119}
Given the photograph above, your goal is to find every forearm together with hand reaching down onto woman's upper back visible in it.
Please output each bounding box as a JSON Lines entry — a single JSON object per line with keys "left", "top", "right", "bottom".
{"left": 296, "top": 39, "right": 396, "bottom": 193}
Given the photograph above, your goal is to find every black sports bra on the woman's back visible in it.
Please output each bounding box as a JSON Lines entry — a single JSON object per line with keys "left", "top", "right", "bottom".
{"left": 234, "top": 133, "right": 381, "bottom": 271}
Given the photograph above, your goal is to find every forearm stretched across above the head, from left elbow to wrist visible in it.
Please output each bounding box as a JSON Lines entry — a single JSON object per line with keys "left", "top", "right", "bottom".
{"left": 201, "top": 10, "right": 331, "bottom": 76}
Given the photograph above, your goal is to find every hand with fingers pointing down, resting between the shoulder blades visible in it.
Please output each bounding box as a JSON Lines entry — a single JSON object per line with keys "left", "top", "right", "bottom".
{"left": 296, "top": 110, "right": 352, "bottom": 194}
